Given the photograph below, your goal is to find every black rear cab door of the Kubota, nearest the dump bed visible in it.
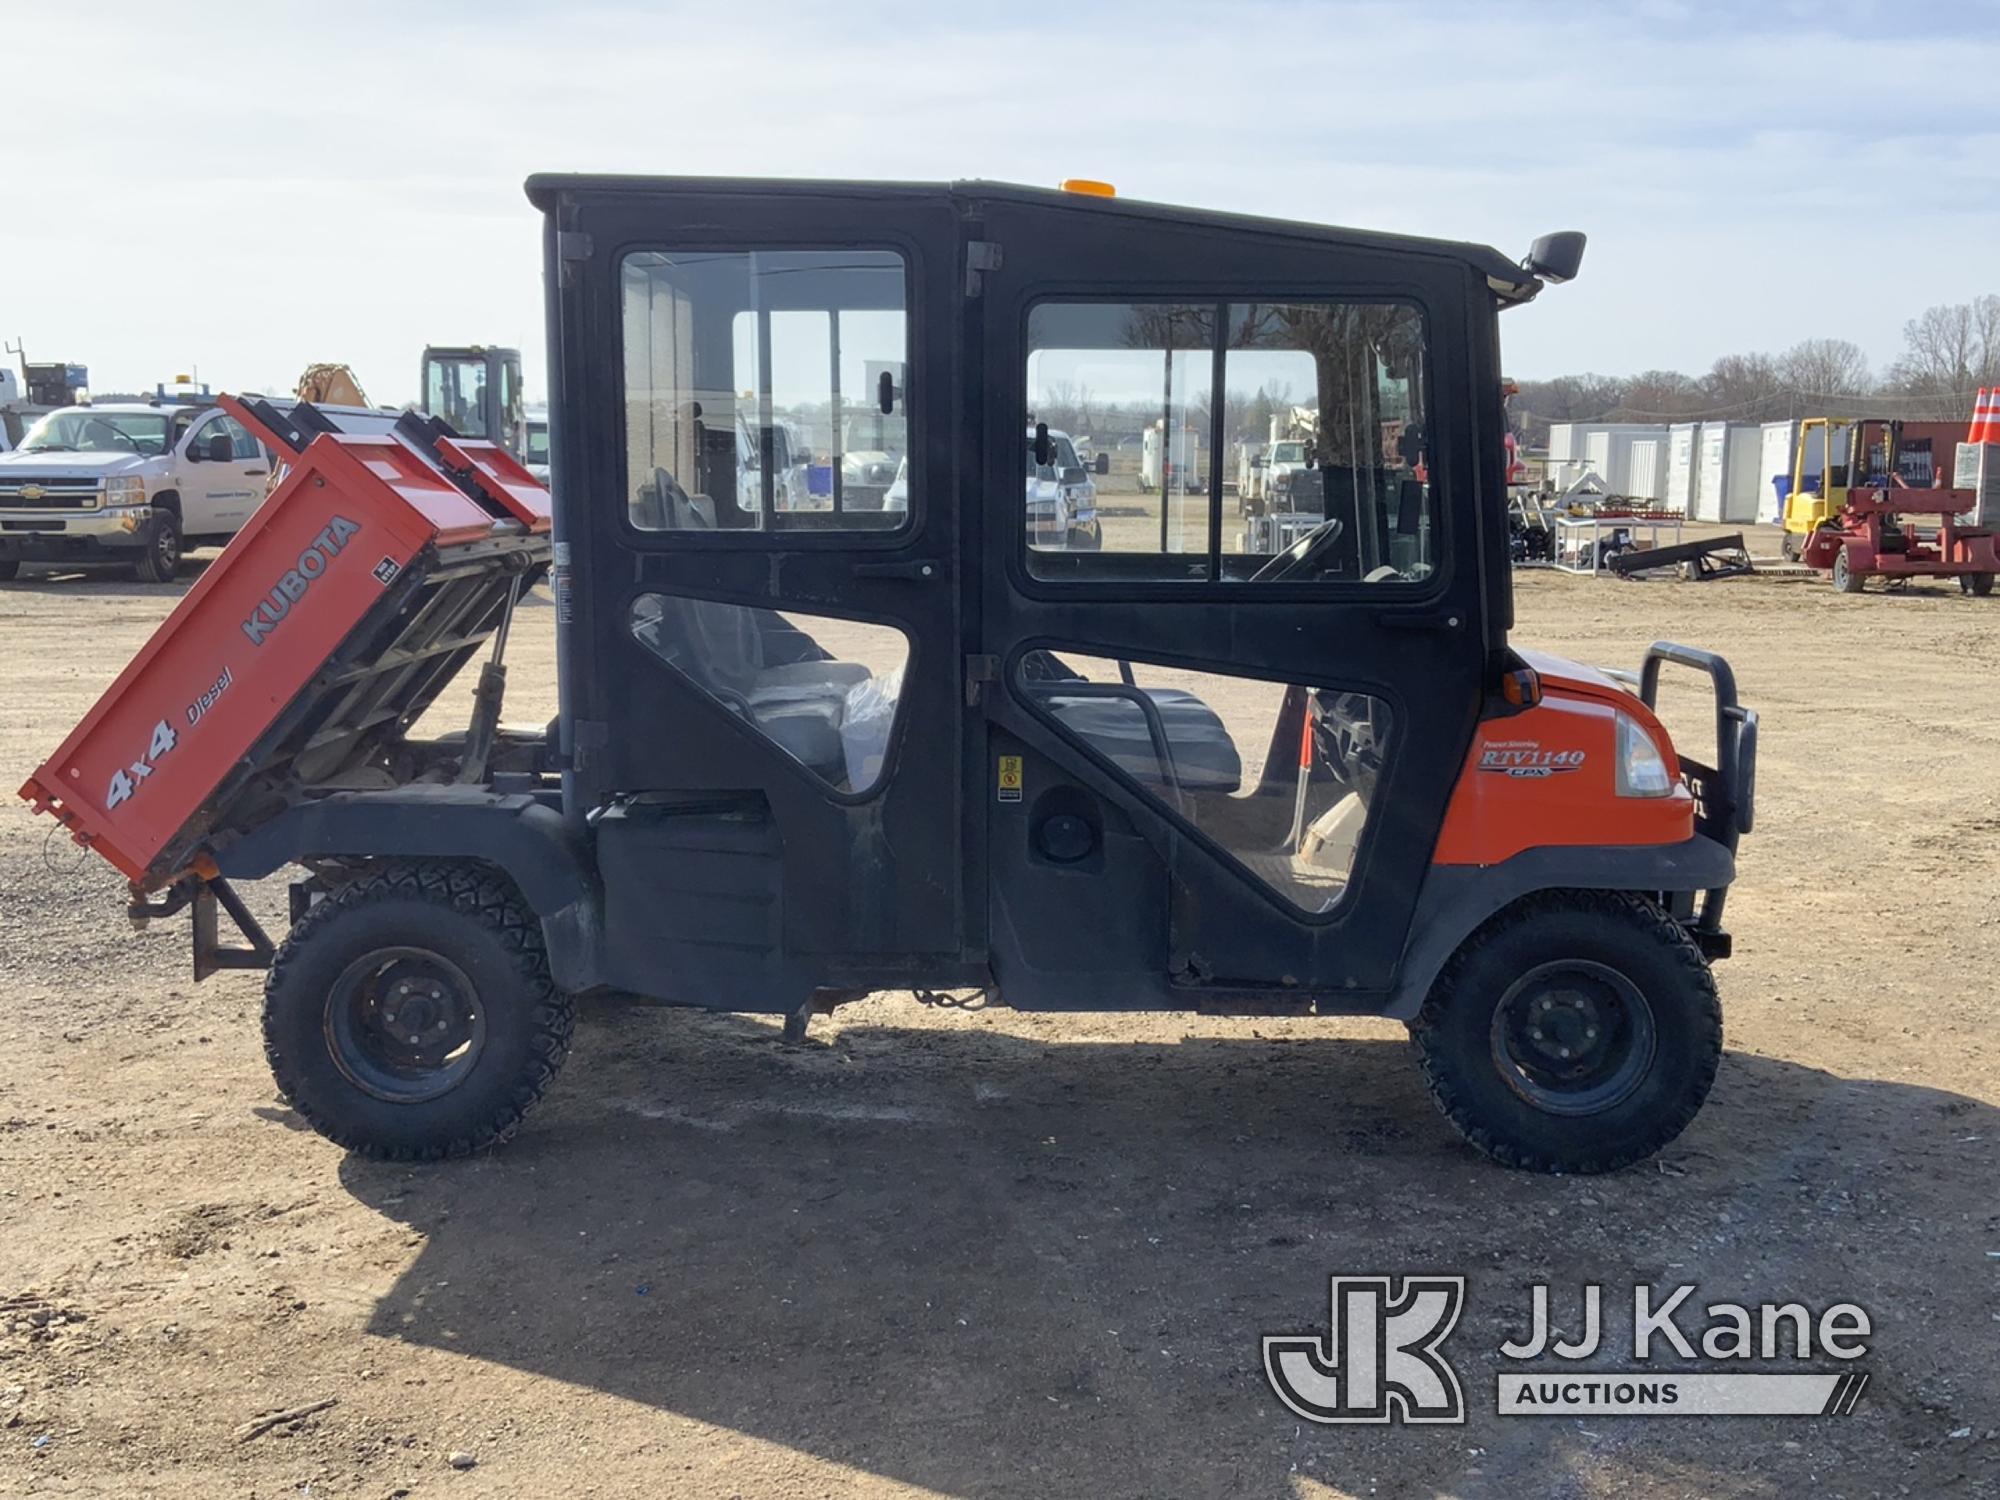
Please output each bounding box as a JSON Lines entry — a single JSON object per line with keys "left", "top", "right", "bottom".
{"left": 530, "top": 178, "right": 964, "bottom": 1010}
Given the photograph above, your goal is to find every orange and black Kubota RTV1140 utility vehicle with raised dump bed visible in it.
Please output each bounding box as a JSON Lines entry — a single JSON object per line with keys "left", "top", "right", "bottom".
{"left": 24, "top": 176, "right": 1756, "bottom": 1172}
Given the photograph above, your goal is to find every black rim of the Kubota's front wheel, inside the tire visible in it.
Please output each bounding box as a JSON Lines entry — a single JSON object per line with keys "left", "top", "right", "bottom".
{"left": 1490, "top": 958, "right": 1658, "bottom": 1114}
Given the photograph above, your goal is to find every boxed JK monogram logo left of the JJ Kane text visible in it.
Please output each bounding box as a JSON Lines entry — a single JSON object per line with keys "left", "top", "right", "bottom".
{"left": 1264, "top": 1276, "right": 1466, "bottom": 1422}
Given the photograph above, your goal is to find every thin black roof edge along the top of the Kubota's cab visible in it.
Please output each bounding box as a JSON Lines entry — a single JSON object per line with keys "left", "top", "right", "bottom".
{"left": 526, "top": 172, "right": 1542, "bottom": 302}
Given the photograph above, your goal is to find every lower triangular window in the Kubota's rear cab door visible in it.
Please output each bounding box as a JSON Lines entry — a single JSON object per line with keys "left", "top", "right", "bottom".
{"left": 630, "top": 594, "right": 910, "bottom": 792}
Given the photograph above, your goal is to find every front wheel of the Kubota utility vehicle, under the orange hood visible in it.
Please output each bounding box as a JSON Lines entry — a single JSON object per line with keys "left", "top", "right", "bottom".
{"left": 1410, "top": 890, "right": 1722, "bottom": 1172}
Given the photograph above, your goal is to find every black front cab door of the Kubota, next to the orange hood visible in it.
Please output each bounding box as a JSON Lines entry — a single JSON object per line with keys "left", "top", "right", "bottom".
{"left": 972, "top": 194, "right": 1502, "bottom": 1010}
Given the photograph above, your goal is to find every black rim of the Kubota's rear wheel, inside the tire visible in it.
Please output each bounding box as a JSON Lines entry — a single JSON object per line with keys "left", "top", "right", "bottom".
{"left": 326, "top": 948, "right": 486, "bottom": 1104}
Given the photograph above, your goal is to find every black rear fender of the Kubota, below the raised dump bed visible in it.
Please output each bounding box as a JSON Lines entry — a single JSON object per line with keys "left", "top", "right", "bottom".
{"left": 214, "top": 786, "right": 604, "bottom": 992}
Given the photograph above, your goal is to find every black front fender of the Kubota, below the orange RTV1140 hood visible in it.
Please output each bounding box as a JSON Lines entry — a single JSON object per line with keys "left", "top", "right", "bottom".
{"left": 1380, "top": 834, "right": 1736, "bottom": 1020}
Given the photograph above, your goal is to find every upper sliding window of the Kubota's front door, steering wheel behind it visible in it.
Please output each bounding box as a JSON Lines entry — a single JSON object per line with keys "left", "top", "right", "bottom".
{"left": 1024, "top": 302, "right": 1438, "bottom": 586}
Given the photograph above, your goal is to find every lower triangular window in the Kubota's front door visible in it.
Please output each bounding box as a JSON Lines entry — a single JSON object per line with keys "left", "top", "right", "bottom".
{"left": 1016, "top": 650, "right": 1394, "bottom": 916}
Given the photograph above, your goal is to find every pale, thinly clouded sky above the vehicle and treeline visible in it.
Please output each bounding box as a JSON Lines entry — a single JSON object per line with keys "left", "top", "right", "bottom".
{"left": 0, "top": 0, "right": 2000, "bottom": 402}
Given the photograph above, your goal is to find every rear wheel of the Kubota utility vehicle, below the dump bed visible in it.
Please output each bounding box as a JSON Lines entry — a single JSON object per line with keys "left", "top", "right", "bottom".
{"left": 264, "top": 864, "right": 572, "bottom": 1162}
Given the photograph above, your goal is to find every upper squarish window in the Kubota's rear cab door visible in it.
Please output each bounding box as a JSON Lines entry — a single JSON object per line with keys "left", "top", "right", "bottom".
{"left": 622, "top": 250, "right": 910, "bottom": 532}
